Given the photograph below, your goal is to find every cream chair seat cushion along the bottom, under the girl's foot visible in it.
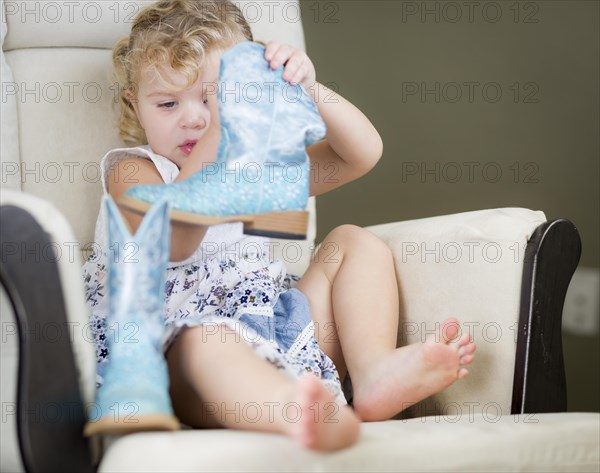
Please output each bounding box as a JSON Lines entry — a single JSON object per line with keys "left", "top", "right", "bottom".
{"left": 99, "top": 410, "right": 600, "bottom": 472}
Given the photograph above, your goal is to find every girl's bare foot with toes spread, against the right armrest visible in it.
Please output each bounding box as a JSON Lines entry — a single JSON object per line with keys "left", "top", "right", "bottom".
{"left": 352, "top": 317, "right": 476, "bottom": 421}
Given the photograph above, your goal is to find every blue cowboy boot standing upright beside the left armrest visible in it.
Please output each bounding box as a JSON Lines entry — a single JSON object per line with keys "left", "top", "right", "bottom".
{"left": 84, "top": 197, "right": 179, "bottom": 436}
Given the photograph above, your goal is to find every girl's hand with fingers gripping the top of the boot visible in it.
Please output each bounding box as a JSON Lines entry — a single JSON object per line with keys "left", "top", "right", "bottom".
{"left": 265, "top": 41, "right": 317, "bottom": 92}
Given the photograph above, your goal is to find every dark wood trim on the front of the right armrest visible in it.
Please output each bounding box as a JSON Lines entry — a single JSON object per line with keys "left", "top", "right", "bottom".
{"left": 511, "top": 219, "right": 581, "bottom": 414}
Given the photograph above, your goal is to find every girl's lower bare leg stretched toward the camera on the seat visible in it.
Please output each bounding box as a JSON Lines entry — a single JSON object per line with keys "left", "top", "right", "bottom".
{"left": 167, "top": 325, "right": 360, "bottom": 450}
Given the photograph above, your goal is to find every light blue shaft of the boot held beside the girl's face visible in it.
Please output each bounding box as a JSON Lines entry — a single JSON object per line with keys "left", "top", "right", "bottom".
{"left": 218, "top": 42, "right": 326, "bottom": 168}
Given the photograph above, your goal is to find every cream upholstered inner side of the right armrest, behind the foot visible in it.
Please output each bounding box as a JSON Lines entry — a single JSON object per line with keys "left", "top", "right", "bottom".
{"left": 360, "top": 208, "right": 548, "bottom": 417}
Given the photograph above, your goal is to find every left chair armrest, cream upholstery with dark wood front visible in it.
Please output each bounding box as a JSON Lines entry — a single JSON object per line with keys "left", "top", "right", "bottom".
{"left": 0, "top": 189, "right": 95, "bottom": 471}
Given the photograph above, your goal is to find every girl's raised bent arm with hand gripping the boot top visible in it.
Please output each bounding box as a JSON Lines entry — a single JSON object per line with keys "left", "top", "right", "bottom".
{"left": 265, "top": 41, "right": 383, "bottom": 195}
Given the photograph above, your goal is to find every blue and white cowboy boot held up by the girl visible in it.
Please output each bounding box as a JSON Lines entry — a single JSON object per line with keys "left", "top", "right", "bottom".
{"left": 119, "top": 42, "right": 326, "bottom": 239}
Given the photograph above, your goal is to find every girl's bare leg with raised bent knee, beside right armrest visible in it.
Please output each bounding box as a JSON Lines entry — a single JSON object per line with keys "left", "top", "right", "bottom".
{"left": 298, "top": 225, "right": 475, "bottom": 420}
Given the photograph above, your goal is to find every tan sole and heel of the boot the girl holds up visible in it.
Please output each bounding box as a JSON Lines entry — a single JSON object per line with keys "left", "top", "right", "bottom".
{"left": 117, "top": 195, "right": 309, "bottom": 240}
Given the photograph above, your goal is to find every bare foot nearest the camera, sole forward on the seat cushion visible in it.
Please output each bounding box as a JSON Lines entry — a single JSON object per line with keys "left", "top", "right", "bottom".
{"left": 288, "top": 375, "right": 360, "bottom": 451}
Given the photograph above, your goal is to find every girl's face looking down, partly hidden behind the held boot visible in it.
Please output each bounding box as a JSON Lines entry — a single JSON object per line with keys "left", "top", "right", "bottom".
{"left": 132, "top": 49, "right": 221, "bottom": 168}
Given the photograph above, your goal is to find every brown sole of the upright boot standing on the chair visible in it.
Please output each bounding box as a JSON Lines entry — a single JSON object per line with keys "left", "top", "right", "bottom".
{"left": 83, "top": 414, "right": 181, "bottom": 437}
